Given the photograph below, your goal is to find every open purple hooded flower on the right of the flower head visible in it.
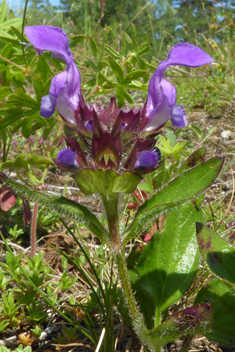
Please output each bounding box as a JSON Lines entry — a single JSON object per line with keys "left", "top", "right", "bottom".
{"left": 142, "top": 43, "right": 213, "bottom": 132}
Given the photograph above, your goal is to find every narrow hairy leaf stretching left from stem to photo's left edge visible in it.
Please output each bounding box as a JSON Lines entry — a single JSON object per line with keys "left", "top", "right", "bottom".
{"left": 0, "top": 172, "right": 109, "bottom": 244}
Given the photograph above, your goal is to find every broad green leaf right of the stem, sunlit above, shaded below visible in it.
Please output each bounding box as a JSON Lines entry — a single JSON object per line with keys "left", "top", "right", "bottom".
{"left": 130, "top": 202, "right": 202, "bottom": 328}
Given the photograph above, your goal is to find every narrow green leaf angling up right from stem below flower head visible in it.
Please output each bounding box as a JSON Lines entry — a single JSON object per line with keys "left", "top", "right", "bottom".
{"left": 124, "top": 156, "right": 224, "bottom": 244}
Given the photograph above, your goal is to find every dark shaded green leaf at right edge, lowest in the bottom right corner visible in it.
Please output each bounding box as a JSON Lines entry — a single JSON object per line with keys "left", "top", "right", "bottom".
{"left": 195, "top": 279, "right": 235, "bottom": 346}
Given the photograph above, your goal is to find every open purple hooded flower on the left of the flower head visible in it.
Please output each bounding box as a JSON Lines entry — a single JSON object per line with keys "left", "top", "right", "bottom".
{"left": 25, "top": 26, "right": 81, "bottom": 124}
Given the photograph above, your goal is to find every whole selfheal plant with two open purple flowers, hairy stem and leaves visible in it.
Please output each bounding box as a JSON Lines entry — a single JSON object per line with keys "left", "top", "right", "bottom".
{"left": 0, "top": 26, "right": 228, "bottom": 351}
